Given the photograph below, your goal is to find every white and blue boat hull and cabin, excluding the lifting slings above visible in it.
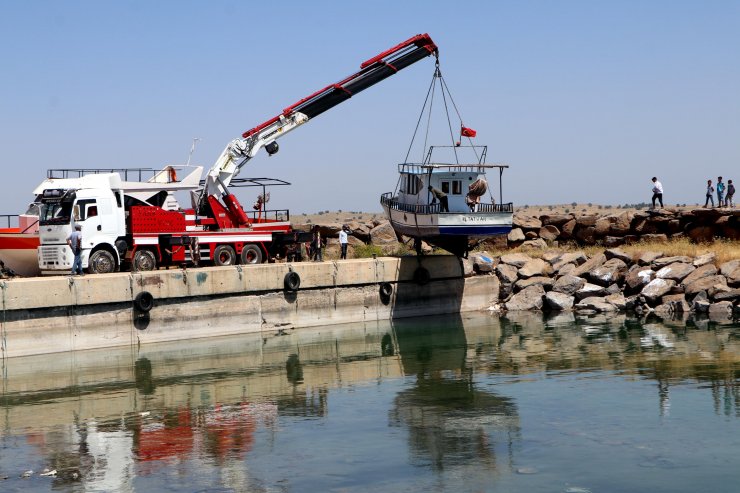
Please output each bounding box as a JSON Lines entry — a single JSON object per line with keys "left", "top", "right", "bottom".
{"left": 380, "top": 146, "right": 514, "bottom": 257}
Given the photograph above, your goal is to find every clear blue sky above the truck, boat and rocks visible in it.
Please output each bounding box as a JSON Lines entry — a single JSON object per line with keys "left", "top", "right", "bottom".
{"left": 0, "top": 0, "right": 740, "bottom": 213}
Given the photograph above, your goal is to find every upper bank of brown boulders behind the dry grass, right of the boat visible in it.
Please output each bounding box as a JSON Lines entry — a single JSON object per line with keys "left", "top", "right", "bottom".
{"left": 507, "top": 208, "right": 740, "bottom": 249}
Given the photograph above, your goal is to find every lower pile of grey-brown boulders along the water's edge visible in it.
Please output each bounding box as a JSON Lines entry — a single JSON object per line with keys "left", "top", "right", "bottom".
{"left": 463, "top": 248, "right": 740, "bottom": 320}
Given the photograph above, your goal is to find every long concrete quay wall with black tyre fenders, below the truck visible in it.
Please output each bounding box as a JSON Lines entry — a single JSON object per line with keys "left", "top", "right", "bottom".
{"left": 0, "top": 256, "right": 498, "bottom": 357}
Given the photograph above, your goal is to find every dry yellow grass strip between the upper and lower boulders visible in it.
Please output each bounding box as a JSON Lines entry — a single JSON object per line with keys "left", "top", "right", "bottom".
{"left": 487, "top": 238, "right": 740, "bottom": 266}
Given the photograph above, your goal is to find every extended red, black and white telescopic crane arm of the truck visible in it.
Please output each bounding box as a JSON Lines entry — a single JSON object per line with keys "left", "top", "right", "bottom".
{"left": 198, "top": 34, "right": 438, "bottom": 212}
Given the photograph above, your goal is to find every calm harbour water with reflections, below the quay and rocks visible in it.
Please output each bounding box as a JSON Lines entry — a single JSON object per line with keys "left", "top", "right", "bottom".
{"left": 0, "top": 313, "right": 740, "bottom": 493}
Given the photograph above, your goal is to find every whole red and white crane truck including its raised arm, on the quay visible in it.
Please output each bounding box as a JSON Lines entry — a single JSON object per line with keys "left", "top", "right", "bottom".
{"left": 38, "top": 34, "right": 438, "bottom": 274}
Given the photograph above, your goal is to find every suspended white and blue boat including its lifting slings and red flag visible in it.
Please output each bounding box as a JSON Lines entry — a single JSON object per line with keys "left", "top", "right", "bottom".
{"left": 380, "top": 61, "right": 514, "bottom": 257}
